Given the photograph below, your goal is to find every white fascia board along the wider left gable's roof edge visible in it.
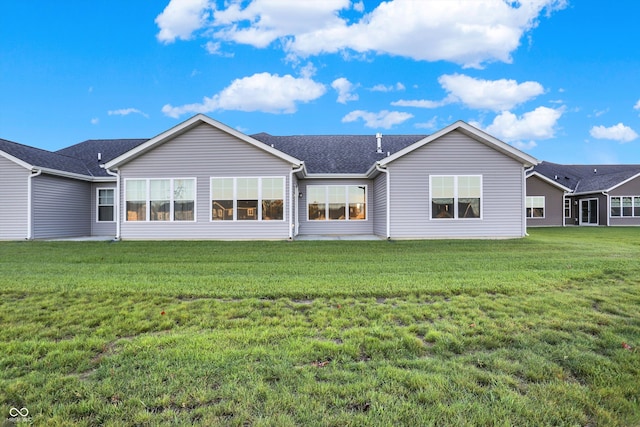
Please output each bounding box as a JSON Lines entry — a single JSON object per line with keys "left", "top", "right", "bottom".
{"left": 104, "top": 114, "right": 302, "bottom": 169}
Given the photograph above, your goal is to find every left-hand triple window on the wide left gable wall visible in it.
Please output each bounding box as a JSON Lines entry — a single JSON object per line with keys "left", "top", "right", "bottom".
{"left": 125, "top": 178, "right": 196, "bottom": 221}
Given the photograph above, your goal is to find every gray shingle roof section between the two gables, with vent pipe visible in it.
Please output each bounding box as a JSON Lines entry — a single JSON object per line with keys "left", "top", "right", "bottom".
{"left": 251, "top": 133, "right": 427, "bottom": 174}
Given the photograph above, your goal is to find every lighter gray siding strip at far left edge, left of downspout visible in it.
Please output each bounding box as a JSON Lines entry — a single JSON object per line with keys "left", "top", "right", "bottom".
{"left": 0, "top": 156, "right": 30, "bottom": 240}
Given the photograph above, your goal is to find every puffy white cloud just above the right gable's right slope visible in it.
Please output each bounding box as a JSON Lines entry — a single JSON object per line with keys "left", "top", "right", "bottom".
{"left": 485, "top": 107, "right": 564, "bottom": 146}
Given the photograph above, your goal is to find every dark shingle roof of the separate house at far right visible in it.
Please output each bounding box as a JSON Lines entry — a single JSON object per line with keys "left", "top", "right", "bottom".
{"left": 533, "top": 162, "right": 640, "bottom": 193}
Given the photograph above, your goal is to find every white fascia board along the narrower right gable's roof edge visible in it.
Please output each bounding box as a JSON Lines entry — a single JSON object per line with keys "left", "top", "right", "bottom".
{"left": 378, "top": 120, "right": 540, "bottom": 167}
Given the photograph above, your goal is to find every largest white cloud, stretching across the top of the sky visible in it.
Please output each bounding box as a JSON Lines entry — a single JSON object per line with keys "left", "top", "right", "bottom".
{"left": 156, "top": 0, "right": 567, "bottom": 68}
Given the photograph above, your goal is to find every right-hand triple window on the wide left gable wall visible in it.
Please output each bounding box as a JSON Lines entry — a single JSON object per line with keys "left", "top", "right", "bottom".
{"left": 211, "top": 177, "right": 285, "bottom": 221}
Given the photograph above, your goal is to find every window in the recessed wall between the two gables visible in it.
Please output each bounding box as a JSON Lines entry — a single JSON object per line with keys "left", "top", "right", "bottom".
{"left": 307, "top": 185, "right": 367, "bottom": 221}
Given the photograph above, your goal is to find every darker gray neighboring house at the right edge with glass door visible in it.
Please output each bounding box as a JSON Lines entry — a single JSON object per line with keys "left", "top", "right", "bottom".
{"left": 526, "top": 162, "right": 640, "bottom": 227}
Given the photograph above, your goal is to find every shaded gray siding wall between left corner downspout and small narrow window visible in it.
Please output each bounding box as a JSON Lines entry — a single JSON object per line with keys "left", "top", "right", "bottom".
{"left": 32, "top": 174, "right": 91, "bottom": 239}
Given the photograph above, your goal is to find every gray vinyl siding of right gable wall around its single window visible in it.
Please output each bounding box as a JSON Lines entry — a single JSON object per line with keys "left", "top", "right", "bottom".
{"left": 388, "top": 131, "right": 526, "bottom": 238}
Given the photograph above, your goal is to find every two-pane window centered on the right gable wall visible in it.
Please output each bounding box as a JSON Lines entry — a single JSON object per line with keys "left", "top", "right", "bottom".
{"left": 429, "top": 175, "right": 482, "bottom": 219}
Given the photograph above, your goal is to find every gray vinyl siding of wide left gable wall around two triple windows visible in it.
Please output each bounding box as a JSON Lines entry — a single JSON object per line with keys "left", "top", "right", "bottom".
{"left": 120, "top": 124, "right": 292, "bottom": 240}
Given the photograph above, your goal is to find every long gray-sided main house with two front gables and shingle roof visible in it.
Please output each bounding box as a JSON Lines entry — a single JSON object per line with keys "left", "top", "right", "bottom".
{"left": 0, "top": 114, "right": 538, "bottom": 240}
